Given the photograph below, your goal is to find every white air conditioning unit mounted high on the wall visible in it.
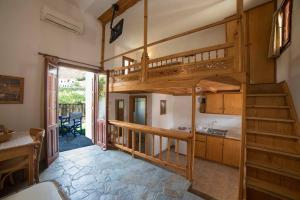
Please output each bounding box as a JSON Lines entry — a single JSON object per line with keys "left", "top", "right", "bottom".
{"left": 41, "top": 6, "right": 83, "bottom": 34}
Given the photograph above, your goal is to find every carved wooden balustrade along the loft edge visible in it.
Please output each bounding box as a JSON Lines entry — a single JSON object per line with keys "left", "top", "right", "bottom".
{"left": 111, "top": 43, "right": 239, "bottom": 83}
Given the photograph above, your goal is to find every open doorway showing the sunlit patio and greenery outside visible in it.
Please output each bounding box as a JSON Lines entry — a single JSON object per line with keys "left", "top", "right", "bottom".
{"left": 58, "top": 66, "right": 94, "bottom": 152}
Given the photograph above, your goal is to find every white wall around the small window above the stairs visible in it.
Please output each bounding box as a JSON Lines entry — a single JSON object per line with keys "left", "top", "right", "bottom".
{"left": 277, "top": 0, "right": 300, "bottom": 116}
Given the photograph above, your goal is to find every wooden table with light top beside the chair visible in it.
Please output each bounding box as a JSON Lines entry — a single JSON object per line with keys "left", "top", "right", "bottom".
{"left": 0, "top": 131, "right": 36, "bottom": 185}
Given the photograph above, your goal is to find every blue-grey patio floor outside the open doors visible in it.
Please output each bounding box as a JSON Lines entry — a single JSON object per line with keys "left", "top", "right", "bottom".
{"left": 59, "top": 133, "right": 93, "bottom": 152}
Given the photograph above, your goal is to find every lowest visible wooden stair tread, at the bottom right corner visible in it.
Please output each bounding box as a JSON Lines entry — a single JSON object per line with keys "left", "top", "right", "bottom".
{"left": 246, "top": 177, "right": 300, "bottom": 199}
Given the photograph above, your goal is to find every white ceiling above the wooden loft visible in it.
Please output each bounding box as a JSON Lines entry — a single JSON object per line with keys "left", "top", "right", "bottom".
{"left": 69, "top": 0, "right": 270, "bottom": 53}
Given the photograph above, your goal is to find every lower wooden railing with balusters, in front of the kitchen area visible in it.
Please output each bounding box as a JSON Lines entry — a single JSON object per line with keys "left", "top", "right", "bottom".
{"left": 109, "top": 120, "right": 193, "bottom": 180}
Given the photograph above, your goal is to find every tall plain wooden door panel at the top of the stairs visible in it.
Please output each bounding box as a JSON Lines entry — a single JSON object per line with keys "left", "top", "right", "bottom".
{"left": 246, "top": 1, "right": 276, "bottom": 84}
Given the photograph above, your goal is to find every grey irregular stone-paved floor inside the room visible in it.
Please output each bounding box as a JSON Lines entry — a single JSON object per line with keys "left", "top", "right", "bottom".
{"left": 40, "top": 146, "right": 201, "bottom": 200}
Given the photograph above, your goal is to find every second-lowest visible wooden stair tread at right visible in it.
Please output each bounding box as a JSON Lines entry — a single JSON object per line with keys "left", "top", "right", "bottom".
{"left": 246, "top": 161, "right": 300, "bottom": 180}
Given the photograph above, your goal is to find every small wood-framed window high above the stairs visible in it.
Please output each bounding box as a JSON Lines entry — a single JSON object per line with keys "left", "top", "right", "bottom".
{"left": 269, "top": 0, "right": 292, "bottom": 57}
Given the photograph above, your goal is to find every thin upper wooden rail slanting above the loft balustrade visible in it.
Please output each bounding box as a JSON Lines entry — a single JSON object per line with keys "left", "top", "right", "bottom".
{"left": 103, "top": 15, "right": 241, "bottom": 63}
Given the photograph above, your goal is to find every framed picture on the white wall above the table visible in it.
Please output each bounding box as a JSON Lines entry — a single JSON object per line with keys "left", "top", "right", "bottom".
{"left": 0, "top": 75, "right": 24, "bottom": 104}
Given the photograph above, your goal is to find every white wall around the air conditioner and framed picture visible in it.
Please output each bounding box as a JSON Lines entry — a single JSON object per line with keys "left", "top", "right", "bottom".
{"left": 0, "top": 0, "right": 101, "bottom": 130}
